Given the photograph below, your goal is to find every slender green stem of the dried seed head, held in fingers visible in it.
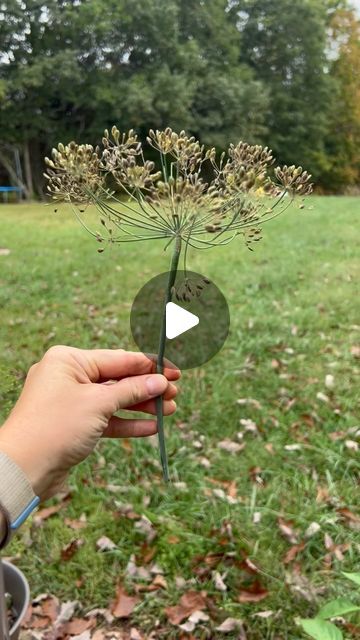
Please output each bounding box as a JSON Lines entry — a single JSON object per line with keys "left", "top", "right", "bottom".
{"left": 156, "top": 236, "right": 181, "bottom": 482}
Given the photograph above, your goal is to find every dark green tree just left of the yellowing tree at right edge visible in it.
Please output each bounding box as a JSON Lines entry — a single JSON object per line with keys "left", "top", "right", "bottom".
{"left": 232, "top": 0, "right": 330, "bottom": 177}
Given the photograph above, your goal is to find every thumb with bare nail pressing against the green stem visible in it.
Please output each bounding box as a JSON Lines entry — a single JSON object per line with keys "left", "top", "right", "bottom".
{"left": 101, "top": 373, "right": 169, "bottom": 413}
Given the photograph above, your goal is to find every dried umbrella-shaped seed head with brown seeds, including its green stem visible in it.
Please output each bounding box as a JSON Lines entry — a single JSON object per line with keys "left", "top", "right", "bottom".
{"left": 45, "top": 126, "right": 312, "bottom": 480}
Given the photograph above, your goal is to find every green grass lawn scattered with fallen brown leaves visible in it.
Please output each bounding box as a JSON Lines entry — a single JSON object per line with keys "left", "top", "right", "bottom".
{"left": 0, "top": 197, "right": 360, "bottom": 640}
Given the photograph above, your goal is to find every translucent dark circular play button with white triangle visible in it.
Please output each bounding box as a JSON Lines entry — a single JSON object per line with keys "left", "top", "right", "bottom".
{"left": 130, "top": 271, "right": 230, "bottom": 369}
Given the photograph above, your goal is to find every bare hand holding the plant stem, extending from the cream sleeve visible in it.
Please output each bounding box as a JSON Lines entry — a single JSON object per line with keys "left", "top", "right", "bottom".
{"left": 0, "top": 346, "right": 180, "bottom": 499}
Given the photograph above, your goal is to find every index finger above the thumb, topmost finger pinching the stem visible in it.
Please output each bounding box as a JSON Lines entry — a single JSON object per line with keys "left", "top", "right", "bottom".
{"left": 82, "top": 349, "right": 181, "bottom": 382}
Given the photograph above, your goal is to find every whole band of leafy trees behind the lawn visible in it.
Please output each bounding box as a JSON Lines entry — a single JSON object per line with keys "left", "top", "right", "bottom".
{"left": 0, "top": 0, "right": 360, "bottom": 193}
